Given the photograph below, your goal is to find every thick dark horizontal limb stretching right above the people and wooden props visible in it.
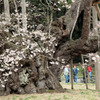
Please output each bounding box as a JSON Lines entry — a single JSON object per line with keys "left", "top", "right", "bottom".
{"left": 55, "top": 39, "right": 98, "bottom": 61}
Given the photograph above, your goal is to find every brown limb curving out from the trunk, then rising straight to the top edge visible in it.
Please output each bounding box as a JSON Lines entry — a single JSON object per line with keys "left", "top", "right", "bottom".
{"left": 55, "top": 0, "right": 92, "bottom": 58}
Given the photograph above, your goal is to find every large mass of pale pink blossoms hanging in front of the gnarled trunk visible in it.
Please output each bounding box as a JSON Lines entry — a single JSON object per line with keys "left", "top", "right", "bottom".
{"left": 0, "top": 18, "right": 58, "bottom": 87}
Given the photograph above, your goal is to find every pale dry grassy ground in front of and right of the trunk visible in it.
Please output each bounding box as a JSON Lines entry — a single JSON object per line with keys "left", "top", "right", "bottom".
{"left": 0, "top": 83, "right": 100, "bottom": 100}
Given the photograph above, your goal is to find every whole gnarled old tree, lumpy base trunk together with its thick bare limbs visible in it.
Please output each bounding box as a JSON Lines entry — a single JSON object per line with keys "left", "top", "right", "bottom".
{"left": 0, "top": 0, "right": 98, "bottom": 95}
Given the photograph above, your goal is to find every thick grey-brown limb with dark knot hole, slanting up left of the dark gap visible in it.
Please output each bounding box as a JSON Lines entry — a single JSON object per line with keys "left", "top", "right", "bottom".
{"left": 51, "top": 0, "right": 85, "bottom": 41}
